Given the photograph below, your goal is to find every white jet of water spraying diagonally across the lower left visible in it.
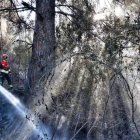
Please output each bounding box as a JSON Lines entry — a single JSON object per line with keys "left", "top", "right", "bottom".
{"left": 0, "top": 85, "right": 49, "bottom": 140}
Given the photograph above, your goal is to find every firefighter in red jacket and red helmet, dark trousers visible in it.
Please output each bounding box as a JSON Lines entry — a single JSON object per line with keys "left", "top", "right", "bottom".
{"left": 0, "top": 54, "right": 13, "bottom": 89}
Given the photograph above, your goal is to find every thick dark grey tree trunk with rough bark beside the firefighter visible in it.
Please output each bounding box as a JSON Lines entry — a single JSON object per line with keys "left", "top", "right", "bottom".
{"left": 28, "top": 0, "right": 55, "bottom": 89}
